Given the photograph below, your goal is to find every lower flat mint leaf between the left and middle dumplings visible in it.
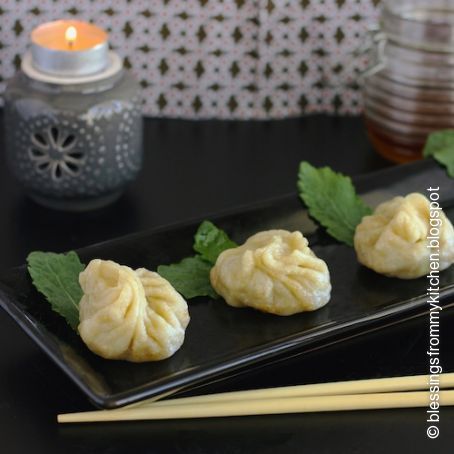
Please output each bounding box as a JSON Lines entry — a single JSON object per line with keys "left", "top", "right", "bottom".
{"left": 158, "top": 256, "right": 218, "bottom": 299}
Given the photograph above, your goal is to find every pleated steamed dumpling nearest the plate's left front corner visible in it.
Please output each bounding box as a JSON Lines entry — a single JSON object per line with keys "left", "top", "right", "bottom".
{"left": 79, "top": 259, "right": 189, "bottom": 362}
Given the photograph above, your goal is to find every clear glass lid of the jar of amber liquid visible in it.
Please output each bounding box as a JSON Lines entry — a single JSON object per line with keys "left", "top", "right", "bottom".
{"left": 381, "top": 0, "right": 454, "bottom": 53}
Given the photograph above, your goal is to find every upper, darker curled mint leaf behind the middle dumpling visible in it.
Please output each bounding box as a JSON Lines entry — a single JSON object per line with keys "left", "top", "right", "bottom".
{"left": 194, "top": 221, "right": 238, "bottom": 265}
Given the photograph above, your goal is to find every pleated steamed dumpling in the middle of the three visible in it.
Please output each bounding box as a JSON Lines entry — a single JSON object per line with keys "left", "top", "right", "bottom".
{"left": 210, "top": 230, "right": 331, "bottom": 315}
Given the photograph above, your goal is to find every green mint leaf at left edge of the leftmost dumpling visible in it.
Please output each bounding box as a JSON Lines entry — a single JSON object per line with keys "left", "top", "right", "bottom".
{"left": 27, "top": 251, "right": 85, "bottom": 331}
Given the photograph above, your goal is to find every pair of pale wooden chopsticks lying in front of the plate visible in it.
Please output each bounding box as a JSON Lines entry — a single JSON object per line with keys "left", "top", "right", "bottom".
{"left": 58, "top": 373, "right": 454, "bottom": 423}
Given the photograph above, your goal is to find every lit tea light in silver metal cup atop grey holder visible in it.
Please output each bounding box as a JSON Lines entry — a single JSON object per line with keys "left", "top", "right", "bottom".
{"left": 31, "top": 20, "right": 109, "bottom": 77}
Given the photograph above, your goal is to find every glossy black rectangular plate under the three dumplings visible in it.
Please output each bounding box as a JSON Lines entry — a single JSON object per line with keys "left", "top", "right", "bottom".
{"left": 0, "top": 162, "right": 454, "bottom": 408}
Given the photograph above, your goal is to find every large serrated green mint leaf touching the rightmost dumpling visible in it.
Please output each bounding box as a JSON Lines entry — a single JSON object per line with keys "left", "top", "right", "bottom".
{"left": 298, "top": 161, "right": 372, "bottom": 246}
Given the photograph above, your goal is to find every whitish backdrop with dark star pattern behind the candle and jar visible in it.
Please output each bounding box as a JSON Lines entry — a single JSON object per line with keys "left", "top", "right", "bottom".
{"left": 0, "top": 0, "right": 379, "bottom": 118}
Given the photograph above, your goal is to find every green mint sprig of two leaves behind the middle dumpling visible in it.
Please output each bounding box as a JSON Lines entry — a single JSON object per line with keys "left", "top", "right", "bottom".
{"left": 158, "top": 221, "right": 237, "bottom": 299}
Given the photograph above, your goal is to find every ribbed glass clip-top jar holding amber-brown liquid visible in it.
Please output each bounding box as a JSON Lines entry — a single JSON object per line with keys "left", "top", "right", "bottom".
{"left": 363, "top": 0, "right": 454, "bottom": 162}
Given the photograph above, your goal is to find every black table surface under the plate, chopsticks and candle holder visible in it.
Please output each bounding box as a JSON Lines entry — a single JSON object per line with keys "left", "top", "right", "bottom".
{"left": 0, "top": 112, "right": 454, "bottom": 454}
